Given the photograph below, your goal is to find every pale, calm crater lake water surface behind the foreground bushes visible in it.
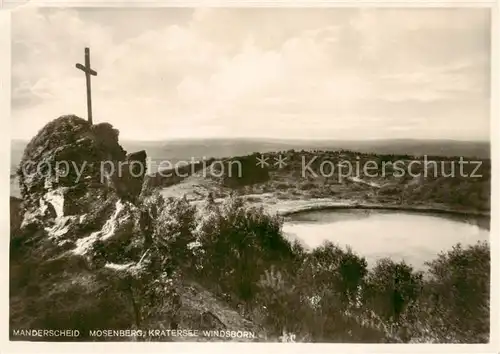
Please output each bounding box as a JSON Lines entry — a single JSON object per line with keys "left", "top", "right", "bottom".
{"left": 283, "top": 209, "right": 489, "bottom": 269}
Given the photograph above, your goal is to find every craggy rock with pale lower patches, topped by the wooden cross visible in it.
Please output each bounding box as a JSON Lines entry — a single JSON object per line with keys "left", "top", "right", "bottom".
{"left": 12, "top": 116, "right": 144, "bottom": 260}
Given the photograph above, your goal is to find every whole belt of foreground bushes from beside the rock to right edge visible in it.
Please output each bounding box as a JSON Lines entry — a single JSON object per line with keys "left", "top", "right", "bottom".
{"left": 139, "top": 197, "right": 490, "bottom": 342}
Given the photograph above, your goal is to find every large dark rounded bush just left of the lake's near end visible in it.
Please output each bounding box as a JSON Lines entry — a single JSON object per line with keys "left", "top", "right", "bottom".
{"left": 193, "top": 197, "right": 292, "bottom": 302}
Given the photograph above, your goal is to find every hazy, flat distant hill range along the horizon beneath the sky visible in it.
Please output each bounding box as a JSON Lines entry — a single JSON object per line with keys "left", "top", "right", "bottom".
{"left": 11, "top": 138, "right": 490, "bottom": 176}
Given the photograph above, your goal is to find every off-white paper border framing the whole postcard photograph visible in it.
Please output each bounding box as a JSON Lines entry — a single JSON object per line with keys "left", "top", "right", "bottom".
{"left": 0, "top": 0, "right": 500, "bottom": 354}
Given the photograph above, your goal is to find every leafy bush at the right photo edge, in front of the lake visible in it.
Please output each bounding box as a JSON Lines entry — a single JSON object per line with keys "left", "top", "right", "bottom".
{"left": 422, "top": 242, "right": 490, "bottom": 343}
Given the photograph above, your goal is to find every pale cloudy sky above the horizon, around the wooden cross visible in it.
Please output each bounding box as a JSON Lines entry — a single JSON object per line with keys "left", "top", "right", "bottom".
{"left": 11, "top": 7, "right": 491, "bottom": 140}
